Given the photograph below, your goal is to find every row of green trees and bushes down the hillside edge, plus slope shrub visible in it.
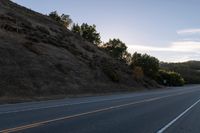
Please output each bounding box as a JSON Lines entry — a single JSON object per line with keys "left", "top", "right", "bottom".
{"left": 49, "top": 11, "right": 186, "bottom": 86}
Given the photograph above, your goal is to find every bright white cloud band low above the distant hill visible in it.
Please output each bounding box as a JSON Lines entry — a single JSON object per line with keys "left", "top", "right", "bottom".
{"left": 128, "top": 41, "right": 200, "bottom": 62}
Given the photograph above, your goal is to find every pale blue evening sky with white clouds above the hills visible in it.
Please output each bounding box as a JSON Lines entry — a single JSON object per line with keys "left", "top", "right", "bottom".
{"left": 13, "top": 0, "right": 200, "bottom": 62}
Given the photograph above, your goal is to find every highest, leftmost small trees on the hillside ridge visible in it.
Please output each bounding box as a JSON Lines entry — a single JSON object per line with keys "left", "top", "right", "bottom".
{"left": 49, "top": 11, "right": 72, "bottom": 28}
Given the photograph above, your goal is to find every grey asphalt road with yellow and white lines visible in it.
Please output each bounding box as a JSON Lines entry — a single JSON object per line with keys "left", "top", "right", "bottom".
{"left": 0, "top": 85, "right": 200, "bottom": 133}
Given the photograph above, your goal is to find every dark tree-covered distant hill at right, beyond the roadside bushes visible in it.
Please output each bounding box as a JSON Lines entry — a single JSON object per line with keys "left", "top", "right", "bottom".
{"left": 160, "top": 61, "right": 200, "bottom": 84}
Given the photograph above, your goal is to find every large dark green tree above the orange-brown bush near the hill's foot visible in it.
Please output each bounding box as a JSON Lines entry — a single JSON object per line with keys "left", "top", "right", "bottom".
{"left": 131, "top": 52, "right": 159, "bottom": 78}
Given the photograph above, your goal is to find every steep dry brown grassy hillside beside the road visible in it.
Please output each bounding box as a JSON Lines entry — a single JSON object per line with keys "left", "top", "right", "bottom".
{"left": 0, "top": 0, "right": 157, "bottom": 96}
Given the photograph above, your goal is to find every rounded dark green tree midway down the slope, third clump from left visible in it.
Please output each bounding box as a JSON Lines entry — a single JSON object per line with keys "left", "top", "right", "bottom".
{"left": 103, "top": 39, "right": 128, "bottom": 59}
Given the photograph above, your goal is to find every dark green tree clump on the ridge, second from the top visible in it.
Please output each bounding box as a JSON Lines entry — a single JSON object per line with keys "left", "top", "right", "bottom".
{"left": 71, "top": 23, "right": 101, "bottom": 45}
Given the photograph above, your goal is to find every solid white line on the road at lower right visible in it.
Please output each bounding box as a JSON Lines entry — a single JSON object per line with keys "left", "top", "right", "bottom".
{"left": 157, "top": 99, "right": 200, "bottom": 133}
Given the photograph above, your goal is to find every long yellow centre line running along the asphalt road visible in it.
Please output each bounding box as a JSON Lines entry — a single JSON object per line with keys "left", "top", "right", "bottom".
{"left": 0, "top": 92, "right": 198, "bottom": 133}
